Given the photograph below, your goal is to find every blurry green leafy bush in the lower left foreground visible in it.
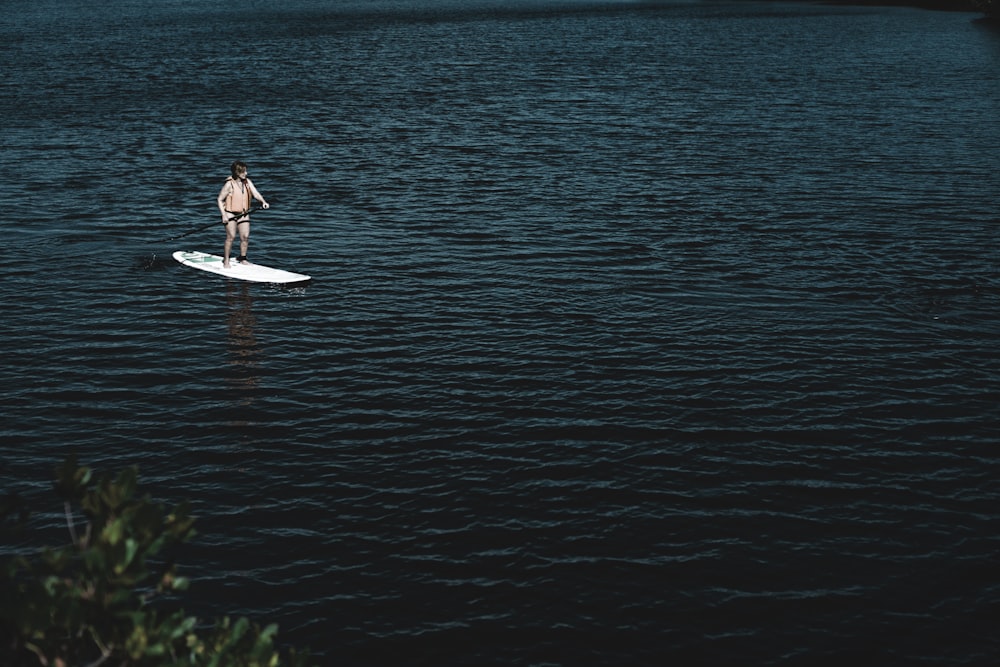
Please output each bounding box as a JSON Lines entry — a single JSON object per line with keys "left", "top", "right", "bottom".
{"left": 0, "top": 458, "right": 307, "bottom": 667}
